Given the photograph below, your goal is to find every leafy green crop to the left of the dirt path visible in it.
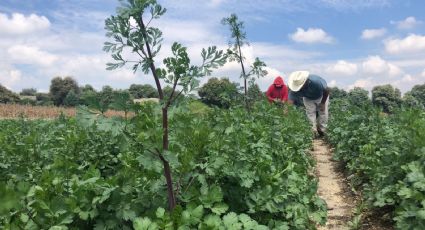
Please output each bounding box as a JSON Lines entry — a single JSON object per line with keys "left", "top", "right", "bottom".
{"left": 0, "top": 103, "right": 326, "bottom": 229}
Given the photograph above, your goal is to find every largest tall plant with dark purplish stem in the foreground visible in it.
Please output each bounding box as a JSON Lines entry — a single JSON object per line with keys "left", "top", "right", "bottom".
{"left": 104, "top": 0, "right": 227, "bottom": 210}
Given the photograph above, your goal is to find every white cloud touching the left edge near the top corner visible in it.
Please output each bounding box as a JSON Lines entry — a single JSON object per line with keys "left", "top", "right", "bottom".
{"left": 0, "top": 13, "right": 50, "bottom": 35}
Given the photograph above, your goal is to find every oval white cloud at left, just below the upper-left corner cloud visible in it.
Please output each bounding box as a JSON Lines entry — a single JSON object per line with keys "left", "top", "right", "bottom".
{"left": 7, "top": 45, "right": 58, "bottom": 66}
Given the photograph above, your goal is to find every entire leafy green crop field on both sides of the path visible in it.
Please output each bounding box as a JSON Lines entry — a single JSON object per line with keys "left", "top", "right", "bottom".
{"left": 0, "top": 100, "right": 425, "bottom": 229}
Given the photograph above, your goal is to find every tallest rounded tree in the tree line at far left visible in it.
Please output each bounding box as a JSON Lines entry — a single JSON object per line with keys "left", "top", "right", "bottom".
{"left": 49, "top": 77, "right": 79, "bottom": 106}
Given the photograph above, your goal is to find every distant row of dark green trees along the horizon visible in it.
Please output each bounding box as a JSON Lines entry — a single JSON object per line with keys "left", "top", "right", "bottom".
{"left": 0, "top": 77, "right": 425, "bottom": 113}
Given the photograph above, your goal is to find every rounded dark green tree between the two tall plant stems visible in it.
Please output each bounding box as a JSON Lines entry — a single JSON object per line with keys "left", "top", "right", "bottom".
{"left": 198, "top": 77, "right": 239, "bottom": 108}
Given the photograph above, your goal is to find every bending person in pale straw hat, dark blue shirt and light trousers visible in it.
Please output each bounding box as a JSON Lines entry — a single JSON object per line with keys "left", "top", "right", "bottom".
{"left": 288, "top": 71, "right": 329, "bottom": 136}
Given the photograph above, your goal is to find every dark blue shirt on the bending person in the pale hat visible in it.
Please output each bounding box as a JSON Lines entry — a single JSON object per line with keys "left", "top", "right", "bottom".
{"left": 288, "top": 74, "right": 328, "bottom": 101}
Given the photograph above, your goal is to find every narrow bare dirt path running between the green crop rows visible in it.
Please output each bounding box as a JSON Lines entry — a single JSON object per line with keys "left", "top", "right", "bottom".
{"left": 312, "top": 140, "right": 355, "bottom": 230}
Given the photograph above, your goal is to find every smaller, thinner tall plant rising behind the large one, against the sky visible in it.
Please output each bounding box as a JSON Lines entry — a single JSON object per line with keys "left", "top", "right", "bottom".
{"left": 221, "top": 14, "right": 267, "bottom": 97}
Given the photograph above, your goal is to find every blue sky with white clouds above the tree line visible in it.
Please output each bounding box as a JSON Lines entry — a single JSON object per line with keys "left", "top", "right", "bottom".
{"left": 0, "top": 0, "right": 425, "bottom": 92}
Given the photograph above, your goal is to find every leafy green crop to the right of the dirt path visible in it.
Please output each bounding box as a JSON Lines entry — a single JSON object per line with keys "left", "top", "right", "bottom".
{"left": 328, "top": 103, "right": 425, "bottom": 229}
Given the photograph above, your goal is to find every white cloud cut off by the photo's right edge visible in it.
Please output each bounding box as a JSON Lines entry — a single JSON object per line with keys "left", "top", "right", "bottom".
{"left": 384, "top": 34, "right": 425, "bottom": 54}
